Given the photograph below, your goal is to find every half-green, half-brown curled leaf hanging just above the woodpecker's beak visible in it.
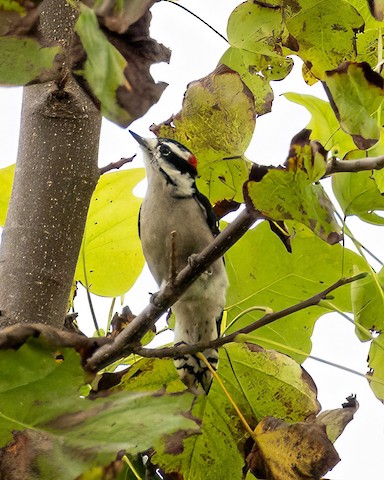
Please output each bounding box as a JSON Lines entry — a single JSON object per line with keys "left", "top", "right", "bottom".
{"left": 72, "top": 7, "right": 170, "bottom": 126}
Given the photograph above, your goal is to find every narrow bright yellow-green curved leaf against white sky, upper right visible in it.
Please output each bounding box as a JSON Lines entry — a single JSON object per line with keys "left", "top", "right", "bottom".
{"left": 284, "top": 92, "right": 356, "bottom": 158}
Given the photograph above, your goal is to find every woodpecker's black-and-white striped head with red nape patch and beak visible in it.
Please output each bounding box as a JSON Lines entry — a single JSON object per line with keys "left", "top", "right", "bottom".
{"left": 129, "top": 130, "right": 197, "bottom": 198}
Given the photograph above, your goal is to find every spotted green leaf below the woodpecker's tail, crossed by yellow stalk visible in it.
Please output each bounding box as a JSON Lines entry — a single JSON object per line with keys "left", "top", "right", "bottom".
{"left": 153, "top": 344, "right": 319, "bottom": 480}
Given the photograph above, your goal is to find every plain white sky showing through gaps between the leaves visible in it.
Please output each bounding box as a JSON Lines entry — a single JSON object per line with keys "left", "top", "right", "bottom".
{"left": 0, "top": 0, "right": 384, "bottom": 480}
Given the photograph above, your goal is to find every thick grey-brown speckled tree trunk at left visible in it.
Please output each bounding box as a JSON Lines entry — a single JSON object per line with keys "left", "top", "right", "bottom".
{"left": 0, "top": 0, "right": 101, "bottom": 327}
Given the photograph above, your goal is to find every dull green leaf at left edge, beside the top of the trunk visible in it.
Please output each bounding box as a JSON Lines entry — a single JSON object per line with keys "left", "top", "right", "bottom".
{"left": 0, "top": 36, "right": 62, "bottom": 85}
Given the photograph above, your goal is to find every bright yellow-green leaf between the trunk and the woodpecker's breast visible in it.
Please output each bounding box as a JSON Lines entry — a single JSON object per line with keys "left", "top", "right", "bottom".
{"left": 75, "top": 168, "right": 145, "bottom": 297}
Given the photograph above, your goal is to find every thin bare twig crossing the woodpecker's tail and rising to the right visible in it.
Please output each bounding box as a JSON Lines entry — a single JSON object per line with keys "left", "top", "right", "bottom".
{"left": 128, "top": 273, "right": 365, "bottom": 358}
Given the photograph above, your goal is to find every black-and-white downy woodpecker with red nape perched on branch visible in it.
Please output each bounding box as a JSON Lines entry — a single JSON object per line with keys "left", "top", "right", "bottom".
{"left": 130, "top": 132, "right": 228, "bottom": 392}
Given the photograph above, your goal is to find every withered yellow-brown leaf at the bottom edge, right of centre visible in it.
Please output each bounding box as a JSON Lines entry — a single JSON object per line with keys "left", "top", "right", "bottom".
{"left": 247, "top": 417, "right": 340, "bottom": 480}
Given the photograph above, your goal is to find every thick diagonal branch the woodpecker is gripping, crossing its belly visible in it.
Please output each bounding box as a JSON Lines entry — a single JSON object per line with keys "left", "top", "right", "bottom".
{"left": 86, "top": 210, "right": 262, "bottom": 372}
